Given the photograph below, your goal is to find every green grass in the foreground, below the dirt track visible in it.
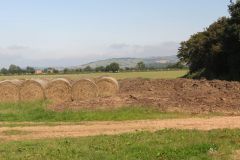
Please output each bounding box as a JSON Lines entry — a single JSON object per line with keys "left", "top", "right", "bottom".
{"left": 0, "top": 130, "right": 240, "bottom": 160}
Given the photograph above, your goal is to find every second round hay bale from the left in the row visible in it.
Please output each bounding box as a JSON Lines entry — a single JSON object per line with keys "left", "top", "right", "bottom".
{"left": 20, "top": 79, "right": 47, "bottom": 101}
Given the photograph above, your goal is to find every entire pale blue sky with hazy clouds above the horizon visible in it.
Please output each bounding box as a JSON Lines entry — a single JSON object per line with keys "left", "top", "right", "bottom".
{"left": 0, "top": 0, "right": 232, "bottom": 67}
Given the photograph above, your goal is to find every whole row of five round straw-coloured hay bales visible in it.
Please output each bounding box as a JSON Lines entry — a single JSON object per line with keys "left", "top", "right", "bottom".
{"left": 0, "top": 77, "right": 119, "bottom": 103}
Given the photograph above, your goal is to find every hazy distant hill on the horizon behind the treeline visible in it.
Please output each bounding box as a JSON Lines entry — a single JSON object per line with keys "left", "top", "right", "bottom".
{"left": 75, "top": 56, "right": 178, "bottom": 68}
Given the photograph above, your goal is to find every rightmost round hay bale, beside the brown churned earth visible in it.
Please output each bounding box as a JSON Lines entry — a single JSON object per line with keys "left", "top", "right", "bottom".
{"left": 96, "top": 77, "right": 119, "bottom": 97}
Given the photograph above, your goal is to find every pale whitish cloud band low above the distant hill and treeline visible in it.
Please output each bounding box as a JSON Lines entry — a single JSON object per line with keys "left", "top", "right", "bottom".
{"left": 0, "top": 42, "right": 179, "bottom": 67}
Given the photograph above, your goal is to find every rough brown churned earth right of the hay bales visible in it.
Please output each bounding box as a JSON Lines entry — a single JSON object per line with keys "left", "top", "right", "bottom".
{"left": 51, "top": 78, "right": 240, "bottom": 115}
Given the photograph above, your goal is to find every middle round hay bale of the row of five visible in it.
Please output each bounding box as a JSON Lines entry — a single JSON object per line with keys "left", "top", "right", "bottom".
{"left": 45, "top": 78, "right": 72, "bottom": 103}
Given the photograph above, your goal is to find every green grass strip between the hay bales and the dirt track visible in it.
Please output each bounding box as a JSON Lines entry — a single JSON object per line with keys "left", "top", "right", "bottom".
{"left": 0, "top": 102, "right": 191, "bottom": 122}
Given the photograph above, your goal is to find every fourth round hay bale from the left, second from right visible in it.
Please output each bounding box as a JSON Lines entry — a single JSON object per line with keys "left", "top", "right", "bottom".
{"left": 72, "top": 79, "right": 98, "bottom": 101}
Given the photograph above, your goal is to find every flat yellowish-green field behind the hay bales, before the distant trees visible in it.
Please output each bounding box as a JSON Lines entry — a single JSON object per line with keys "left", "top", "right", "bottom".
{"left": 0, "top": 70, "right": 188, "bottom": 80}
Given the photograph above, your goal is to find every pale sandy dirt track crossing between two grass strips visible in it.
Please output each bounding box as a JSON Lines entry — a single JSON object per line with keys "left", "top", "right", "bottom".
{"left": 0, "top": 116, "right": 240, "bottom": 141}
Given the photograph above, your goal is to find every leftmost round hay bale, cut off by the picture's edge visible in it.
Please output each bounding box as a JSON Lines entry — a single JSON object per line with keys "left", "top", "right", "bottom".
{"left": 0, "top": 80, "right": 22, "bottom": 102}
